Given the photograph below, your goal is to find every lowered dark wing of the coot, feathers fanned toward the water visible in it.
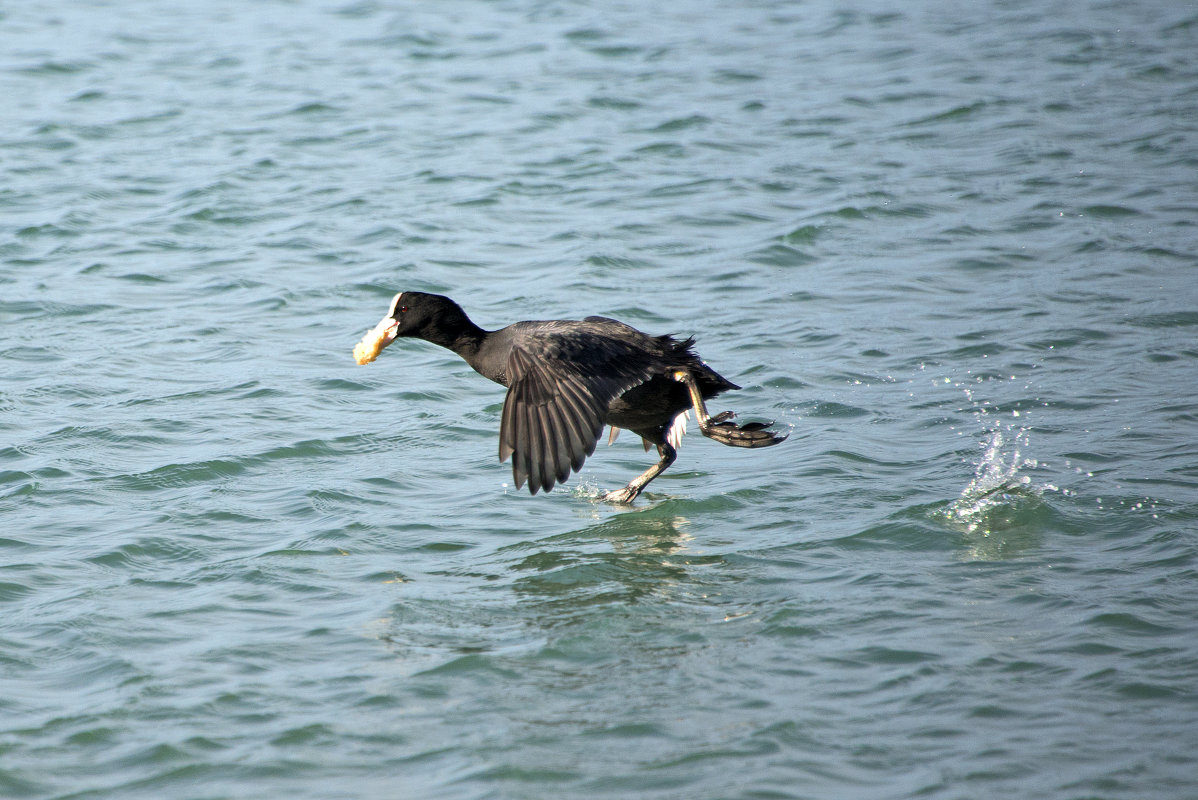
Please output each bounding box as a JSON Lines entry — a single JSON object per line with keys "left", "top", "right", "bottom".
{"left": 500, "top": 331, "right": 653, "bottom": 495}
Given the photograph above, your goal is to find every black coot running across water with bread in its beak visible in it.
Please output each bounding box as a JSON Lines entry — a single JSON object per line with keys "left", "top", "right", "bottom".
{"left": 356, "top": 292, "right": 786, "bottom": 503}
